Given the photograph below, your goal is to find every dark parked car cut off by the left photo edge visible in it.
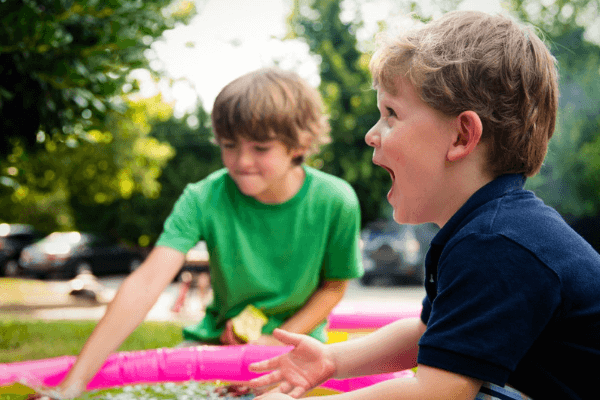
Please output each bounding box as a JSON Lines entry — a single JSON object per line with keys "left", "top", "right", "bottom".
{"left": 0, "top": 223, "right": 43, "bottom": 277}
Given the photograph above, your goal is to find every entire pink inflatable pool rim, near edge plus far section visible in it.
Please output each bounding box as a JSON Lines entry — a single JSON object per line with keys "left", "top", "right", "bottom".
{"left": 0, "top": 301, "right": 421, "bottom": 392}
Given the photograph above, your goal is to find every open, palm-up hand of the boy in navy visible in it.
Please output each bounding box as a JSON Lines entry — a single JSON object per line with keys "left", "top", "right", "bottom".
{"left": 248, "top": 329, "right": 336, "bottom": 400}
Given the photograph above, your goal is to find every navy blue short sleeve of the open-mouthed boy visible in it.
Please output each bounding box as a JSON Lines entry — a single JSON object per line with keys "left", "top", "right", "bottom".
{"left": 418, "top": 234, "right": 561, "bottom": 385}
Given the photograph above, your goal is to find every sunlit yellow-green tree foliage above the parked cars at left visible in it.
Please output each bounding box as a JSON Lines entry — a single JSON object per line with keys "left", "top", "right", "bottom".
{"left": 0, "top": 92, "right": 174, "bottom": 242}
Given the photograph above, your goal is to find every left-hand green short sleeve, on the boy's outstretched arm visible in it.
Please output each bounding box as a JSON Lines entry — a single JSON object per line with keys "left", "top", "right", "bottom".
{"left": 155, "top": 184, "right": 202, "bottom": 253}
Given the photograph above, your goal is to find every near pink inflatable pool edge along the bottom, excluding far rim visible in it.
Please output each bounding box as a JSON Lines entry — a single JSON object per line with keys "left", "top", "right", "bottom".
{"left": 0, "top": 345, "right": 413, "bottom": 392}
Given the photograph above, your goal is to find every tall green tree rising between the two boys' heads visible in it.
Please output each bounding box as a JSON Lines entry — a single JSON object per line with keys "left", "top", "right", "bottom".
{"left": 290, "top": 0, "right": 390, "bottom": 224}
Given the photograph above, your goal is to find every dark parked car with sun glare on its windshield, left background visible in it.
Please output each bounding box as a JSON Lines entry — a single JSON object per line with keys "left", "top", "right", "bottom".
{"left": 19, "top": 232, "right": 144, "bottom": 279}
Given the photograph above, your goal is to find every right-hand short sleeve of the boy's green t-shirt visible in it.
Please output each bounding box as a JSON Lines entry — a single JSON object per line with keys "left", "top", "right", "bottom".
{"left": 323, "top": 184, "right": 363, "bottom": 280}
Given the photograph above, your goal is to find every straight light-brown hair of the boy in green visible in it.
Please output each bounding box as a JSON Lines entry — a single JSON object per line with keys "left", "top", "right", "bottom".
{"left": 212, "top": 68, "right": 331, "bottom": 164}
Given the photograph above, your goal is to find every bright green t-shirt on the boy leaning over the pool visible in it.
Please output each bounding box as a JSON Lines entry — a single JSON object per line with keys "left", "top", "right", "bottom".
{"left": 156, "top": 166, "right": 363, "bottom": 342}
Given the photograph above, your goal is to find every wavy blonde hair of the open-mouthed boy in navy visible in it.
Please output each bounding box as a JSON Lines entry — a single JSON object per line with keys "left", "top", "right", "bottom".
{"left": 370, "top": 11, "right": 558, "bottom": 176}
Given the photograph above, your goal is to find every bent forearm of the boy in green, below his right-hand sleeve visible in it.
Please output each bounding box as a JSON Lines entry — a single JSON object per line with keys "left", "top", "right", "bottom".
{"left": 280, "top": 281, "right": 348, "bottom": 334}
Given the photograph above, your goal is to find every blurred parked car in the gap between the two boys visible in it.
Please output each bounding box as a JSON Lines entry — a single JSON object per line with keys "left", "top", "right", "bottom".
{"left": 361, "top": 221, "right": 438, "bottom": 286}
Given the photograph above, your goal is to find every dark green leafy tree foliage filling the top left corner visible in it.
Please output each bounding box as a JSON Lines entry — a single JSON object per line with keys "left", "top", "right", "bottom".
{"left": 0, "top": 0, "right": 195, "bottom": 158}
